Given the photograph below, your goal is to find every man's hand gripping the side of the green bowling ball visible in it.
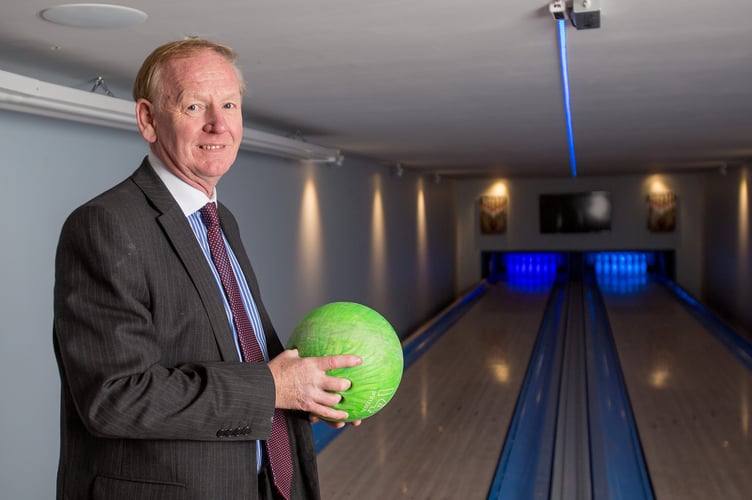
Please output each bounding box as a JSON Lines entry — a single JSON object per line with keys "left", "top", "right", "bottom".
{"left": 269, "top": 349, "right": 363, "bottom": 427}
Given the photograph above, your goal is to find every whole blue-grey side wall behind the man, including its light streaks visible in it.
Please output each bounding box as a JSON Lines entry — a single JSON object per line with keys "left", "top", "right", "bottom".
{"left": 0, "top": 111, "right": 456, "bottom": 500}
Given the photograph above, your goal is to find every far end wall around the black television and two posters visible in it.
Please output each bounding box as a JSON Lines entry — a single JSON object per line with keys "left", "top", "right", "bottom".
{"left": 456, "top": 175, "right": 703, "bottom": 295}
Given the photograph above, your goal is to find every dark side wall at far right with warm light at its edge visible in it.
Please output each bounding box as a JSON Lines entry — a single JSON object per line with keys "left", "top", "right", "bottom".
{"left": 703, "top": 167, "right": 752, "bottom": 333}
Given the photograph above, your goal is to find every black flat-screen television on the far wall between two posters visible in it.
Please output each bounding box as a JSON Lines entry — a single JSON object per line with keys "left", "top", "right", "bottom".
{"left": 539, "top": 191, "right": 611, "bottom": 233}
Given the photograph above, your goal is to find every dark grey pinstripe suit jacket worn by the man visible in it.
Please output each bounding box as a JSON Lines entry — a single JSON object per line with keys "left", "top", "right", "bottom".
{"left": 53, "top": 160, "right": 319, "bottom": 500}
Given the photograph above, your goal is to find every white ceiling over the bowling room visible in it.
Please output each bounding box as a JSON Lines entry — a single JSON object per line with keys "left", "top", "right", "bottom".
{"left": 0, "top": 0, "right": 752, "bottom": 177}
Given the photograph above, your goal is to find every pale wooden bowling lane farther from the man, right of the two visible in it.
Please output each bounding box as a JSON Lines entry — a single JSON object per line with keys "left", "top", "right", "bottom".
{"left": 603, "top": 283, "right": 752, "bottom": 500}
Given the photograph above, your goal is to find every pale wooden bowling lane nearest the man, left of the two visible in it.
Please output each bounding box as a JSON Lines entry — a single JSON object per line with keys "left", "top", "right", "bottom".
{"left": 318, "top": 283, "right": 548, "bottom": 500}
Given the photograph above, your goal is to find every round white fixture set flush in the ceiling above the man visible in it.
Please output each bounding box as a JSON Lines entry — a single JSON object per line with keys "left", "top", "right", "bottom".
{"left": 39, "top": 3, "right": 148, "bottom": 28}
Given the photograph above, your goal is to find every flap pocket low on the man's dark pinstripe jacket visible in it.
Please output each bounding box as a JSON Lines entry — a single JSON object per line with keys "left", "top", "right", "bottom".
{"left": 92, "top": 476, "right": 186, "bottom": 500}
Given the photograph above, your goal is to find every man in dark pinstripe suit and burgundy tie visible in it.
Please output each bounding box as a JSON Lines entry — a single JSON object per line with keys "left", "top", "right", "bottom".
{"left": 54, "top": 39, "right": 361, "bottom": 500}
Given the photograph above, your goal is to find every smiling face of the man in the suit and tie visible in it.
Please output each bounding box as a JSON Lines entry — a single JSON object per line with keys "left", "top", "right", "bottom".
{"left": 137, "top": 50, "right": 243, "bottom": 196}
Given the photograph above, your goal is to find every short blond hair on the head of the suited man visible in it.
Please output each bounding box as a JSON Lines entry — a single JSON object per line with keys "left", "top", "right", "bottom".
{"left": 133, "top": 38, "right": 245, "bottom": 104}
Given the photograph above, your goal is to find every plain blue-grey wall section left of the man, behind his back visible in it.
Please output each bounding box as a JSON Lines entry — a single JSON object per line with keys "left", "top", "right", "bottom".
{"left": 0, "top": 111, "right": 144, "bottom": 500}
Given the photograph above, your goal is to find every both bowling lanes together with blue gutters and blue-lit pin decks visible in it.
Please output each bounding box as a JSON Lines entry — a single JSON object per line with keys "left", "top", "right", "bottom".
{"left": 314, "top": 251, "right": 752, "bottom": 500}
